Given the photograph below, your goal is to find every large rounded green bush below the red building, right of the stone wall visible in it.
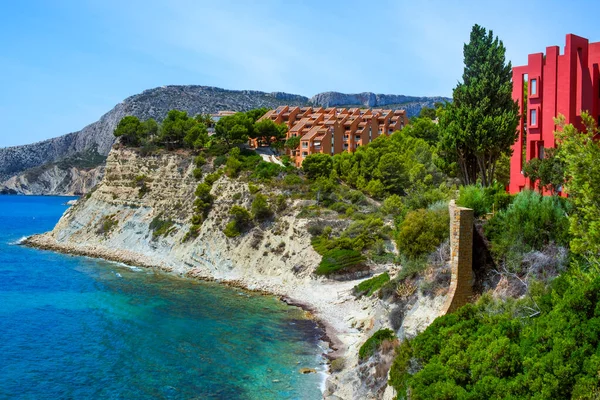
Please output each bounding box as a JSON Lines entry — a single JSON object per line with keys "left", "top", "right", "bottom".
{"left": 485, "top": 191, "right": 570, "bottom": 266}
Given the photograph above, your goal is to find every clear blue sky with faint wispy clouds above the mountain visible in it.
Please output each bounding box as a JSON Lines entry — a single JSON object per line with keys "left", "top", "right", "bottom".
{"left": 0, "top": 0, "right": 600, "bottom": 147}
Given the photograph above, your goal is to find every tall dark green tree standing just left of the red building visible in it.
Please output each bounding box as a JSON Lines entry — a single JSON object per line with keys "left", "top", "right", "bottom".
{"left": 440, "top": 25, "right": 519, "bottom": 186}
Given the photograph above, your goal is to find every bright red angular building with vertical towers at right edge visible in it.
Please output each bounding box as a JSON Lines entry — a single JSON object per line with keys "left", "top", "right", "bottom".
{"left": 509, "top": 34, "right": 600, "bottom": 193}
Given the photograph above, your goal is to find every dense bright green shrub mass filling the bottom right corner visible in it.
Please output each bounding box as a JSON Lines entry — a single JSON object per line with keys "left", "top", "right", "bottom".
{"left": 390, "top": 277, "right": 600, "bottom": 399}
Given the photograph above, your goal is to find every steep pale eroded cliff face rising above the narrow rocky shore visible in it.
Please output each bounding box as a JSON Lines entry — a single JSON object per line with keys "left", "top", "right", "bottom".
{"left": 37, "top": 149, "right": 320, "bottom": 280}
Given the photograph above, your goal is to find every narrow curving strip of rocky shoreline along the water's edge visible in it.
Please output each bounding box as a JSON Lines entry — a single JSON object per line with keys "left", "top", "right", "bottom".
{"left": 24, "top": 234, "right": 346, "bottom": 366}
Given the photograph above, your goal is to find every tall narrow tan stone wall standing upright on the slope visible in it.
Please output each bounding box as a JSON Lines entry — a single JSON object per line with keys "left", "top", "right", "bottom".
{"left": 442, "top": 200, "right": 474, "bottom": 315}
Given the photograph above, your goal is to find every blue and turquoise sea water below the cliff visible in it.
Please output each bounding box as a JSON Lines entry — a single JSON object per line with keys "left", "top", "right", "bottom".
{"left": 0, "top": 196, "right": 323, "bottom": 399}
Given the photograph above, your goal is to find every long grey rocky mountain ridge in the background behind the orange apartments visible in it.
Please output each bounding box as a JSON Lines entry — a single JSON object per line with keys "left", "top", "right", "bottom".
{"left": 0, "top": 85, "right": 448, "bottom": 194}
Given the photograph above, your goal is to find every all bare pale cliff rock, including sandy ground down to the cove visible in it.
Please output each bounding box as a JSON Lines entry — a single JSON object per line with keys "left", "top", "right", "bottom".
{"left": 27, "top": 148, "right": 443, "bottom": 399}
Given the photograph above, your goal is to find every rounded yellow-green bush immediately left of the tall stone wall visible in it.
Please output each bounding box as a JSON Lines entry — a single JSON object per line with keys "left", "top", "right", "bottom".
{"left": 396, "top": 209, "right": 450, "bottom": 258}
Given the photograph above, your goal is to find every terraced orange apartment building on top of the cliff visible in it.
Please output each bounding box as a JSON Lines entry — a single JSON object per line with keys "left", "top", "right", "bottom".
{"left": 259, "top": 106, "right": 408, "bottom": 167}
